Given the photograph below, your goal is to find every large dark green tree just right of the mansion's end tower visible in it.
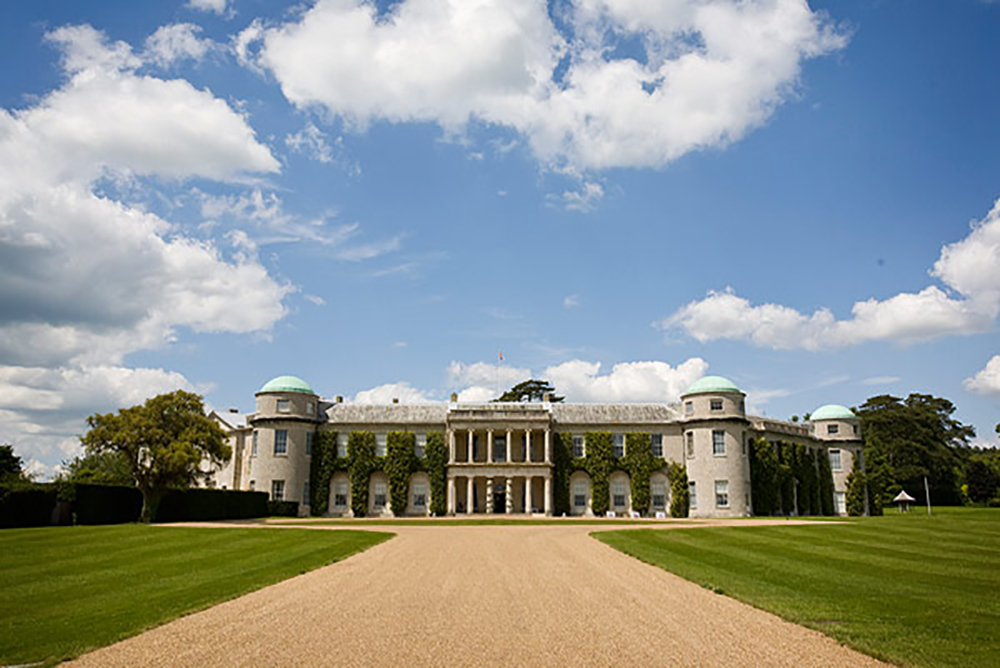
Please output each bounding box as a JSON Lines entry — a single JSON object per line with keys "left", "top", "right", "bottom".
{"left": 857, "top": 393, "right": 976, "bottom": 505}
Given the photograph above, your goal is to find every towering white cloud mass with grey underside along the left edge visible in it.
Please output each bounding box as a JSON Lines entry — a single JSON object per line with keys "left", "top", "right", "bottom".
{"left": 0, "top": 26, "right": 292, "bottom": 473}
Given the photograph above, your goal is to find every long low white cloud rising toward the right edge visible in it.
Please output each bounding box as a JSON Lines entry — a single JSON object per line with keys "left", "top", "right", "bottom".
{"left": 657, "top": 201, "right": 1000, "bottom": 350}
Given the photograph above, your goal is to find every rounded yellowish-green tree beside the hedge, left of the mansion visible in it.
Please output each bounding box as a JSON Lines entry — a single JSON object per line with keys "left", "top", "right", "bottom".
{"left": 80, "top": 390, "right": 232, "bottom": 522}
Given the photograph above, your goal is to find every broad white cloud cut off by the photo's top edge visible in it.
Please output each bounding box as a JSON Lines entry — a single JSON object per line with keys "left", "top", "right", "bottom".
{"left": 250, "top": 0, "right": 847, "bottom": 169}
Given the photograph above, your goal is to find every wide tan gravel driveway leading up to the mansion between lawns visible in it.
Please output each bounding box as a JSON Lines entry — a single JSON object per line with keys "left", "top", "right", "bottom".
{"left": 68, "top": 522, "right": 882, "bottom": 667}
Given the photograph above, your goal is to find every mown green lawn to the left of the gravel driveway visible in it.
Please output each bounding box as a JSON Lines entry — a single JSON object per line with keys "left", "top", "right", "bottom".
{"left": 0, "top": 524, "right": 392, "bottom": 665}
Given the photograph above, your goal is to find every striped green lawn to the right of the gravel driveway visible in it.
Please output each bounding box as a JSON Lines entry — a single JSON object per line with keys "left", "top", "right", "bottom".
{"left": 594, "top": 509, "right": 1000, "bottom": 667}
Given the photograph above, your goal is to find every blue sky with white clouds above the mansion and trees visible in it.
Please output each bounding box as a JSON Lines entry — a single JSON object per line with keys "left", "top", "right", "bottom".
{"left": 0, "top": 0, "right": 1000, "bottom": 476}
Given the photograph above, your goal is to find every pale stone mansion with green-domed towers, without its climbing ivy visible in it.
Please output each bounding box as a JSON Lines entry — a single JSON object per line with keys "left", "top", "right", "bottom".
{"left": 209, "top": 376, "right": 862, "bottom": 517}
